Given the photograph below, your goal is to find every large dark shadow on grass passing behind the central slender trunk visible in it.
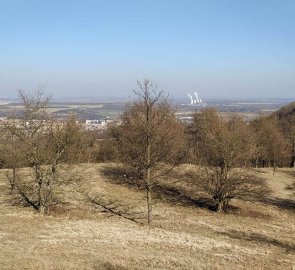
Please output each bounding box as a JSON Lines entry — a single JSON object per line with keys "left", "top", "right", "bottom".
{"left": 102, "top": 167, "right": 215, "bottom": 211}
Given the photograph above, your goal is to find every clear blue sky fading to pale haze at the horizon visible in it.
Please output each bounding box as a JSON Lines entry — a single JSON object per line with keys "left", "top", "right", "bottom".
{"left": 0, "top": 0, "right": 295, "bottom": 99}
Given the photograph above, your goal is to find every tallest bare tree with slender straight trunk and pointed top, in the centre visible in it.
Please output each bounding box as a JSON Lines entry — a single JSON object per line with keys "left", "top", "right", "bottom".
{"left": 113, "top": 80, "right": 183, "bottom": 225}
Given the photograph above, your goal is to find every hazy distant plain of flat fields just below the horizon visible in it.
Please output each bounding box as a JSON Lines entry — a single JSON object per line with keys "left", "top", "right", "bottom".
{"left": 0, "top": 99, "right": 290, "bottom": 120}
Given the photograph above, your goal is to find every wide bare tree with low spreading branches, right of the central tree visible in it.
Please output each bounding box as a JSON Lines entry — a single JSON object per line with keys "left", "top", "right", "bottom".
{"left": 191, "top": 109, "right": 267, "bottom": 212}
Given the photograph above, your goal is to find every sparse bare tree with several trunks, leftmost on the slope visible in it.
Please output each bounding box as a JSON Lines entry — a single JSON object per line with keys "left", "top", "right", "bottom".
{"left": 6, "top": 90, "right": 83, "bottom": 214}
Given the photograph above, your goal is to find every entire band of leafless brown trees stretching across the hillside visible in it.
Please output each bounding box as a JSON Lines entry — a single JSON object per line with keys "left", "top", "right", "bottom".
{"left": 1, "top": 80, "right": 295, "bottom": 224}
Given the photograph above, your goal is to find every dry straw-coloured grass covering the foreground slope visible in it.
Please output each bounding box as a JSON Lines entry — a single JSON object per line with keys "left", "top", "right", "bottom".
{"left": 0, "top": 164, "right": 295, "bottom": 270}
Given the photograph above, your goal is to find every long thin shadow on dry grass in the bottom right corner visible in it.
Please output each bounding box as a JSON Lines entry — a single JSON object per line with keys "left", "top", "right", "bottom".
{"left": 219, "top": 230, "right": 295, "bottom": 253}
